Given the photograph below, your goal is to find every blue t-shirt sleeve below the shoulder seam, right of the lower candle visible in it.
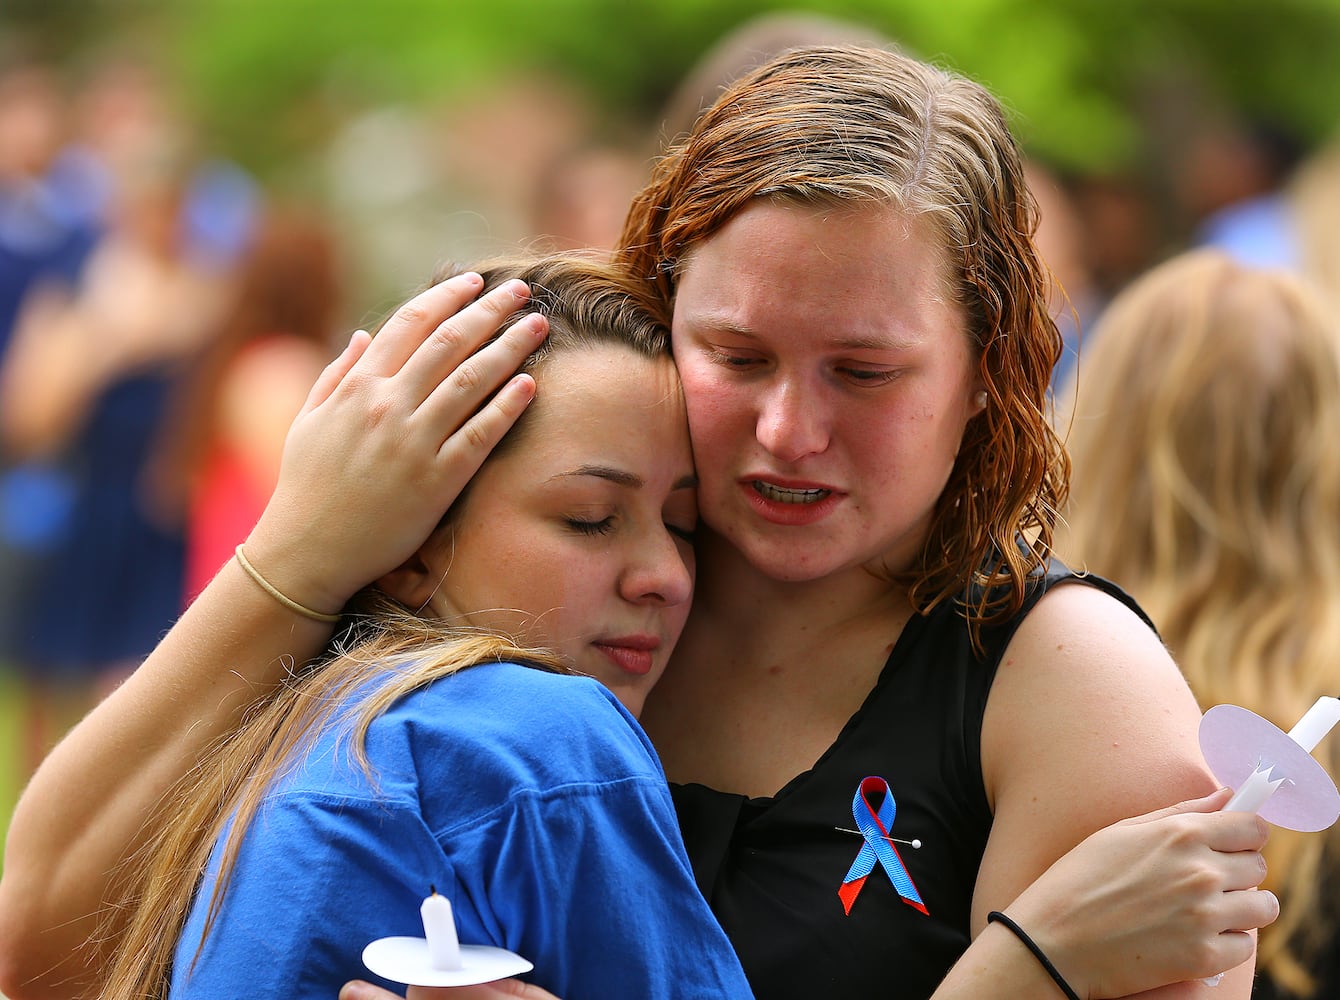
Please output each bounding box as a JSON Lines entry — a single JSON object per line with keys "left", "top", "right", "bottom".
{"left": 460, "top": 779, "right": 752, "bottom": 1000}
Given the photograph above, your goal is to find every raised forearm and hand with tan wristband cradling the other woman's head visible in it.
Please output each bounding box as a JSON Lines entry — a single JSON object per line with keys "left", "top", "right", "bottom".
{"left": 0, "top": 275, "right": 545, "bottom": 1000}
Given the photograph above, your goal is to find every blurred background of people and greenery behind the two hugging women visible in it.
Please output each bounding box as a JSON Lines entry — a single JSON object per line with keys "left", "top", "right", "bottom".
{"left": 0, "top": 0, "right": 1340, "bottom": 991}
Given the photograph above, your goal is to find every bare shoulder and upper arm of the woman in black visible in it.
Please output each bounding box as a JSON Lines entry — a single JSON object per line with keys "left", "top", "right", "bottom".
{"left": 974, "top": 578, "right": 1214, "bottom": 921}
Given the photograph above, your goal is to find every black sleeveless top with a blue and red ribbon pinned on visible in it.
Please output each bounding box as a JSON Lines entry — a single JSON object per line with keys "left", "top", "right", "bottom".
{"left": 673, "top": 564, "right": 1143, "bottom": 1000}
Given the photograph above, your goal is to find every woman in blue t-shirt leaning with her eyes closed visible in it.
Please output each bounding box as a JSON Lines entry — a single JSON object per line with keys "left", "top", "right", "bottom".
{"left": 98, "top": 255, "right": 748, "bottom": 997}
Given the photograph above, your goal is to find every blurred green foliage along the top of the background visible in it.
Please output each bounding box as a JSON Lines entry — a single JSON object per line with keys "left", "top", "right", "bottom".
{"left": 0, "top": 0, "right": 1340, "bottom": 173}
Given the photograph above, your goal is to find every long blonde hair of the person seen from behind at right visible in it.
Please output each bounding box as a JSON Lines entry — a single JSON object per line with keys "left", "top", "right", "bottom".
{"left": 1059, "top": 251, "right": 1340, "bottom": 993}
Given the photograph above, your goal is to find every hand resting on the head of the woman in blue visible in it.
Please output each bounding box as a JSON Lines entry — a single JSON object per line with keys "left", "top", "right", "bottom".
{"left": 247, "top": 273, "right": 548, "bottom": 611}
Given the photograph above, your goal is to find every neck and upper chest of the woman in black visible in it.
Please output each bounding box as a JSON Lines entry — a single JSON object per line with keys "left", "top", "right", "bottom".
{"left": 643, "top": 522, "right": 911, "bottom": 795}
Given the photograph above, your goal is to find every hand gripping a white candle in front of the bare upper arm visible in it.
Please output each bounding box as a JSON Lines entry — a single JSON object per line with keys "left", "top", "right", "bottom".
{"left": 1006, "top": 788, "right": 1280, "bottom": 997}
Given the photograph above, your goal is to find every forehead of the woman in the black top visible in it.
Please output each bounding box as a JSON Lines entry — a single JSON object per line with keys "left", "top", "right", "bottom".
{"left": 674, "top": 200, "right": 966, "bottom": 347}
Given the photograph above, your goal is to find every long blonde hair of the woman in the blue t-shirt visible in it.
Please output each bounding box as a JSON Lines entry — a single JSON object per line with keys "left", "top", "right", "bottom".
{"left": 94, "top": 252, "right": 670, "bottom": 1000}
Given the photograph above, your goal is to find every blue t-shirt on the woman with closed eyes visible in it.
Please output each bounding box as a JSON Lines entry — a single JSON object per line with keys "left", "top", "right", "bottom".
{"left": 172, "top": 664, "right": 750, "bottom": 1000}
